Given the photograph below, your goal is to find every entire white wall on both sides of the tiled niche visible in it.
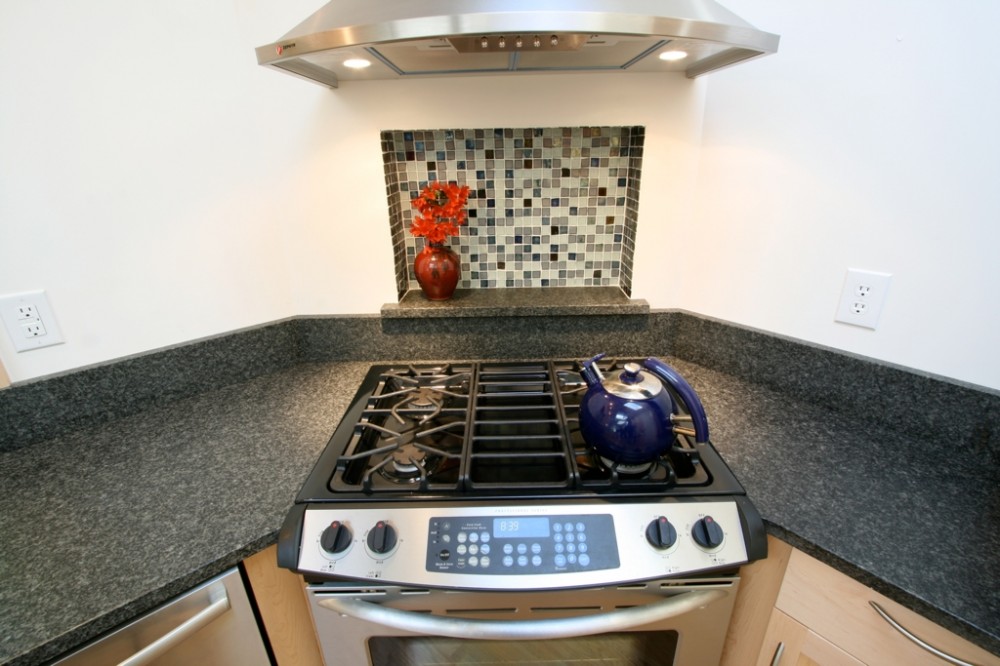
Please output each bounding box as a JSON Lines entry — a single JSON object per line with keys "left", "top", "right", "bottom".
{"left": 0, "top": 0, "right": 1000, "bottom": 388}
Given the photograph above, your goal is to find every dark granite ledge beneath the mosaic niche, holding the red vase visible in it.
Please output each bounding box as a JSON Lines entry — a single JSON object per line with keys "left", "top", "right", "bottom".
{"left": 382, "top": 287, "right": 649, "bottom": 319}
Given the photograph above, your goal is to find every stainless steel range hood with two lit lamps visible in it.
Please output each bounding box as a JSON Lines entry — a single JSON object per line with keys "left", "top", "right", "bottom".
{"left": 257, "top": 0, "right": 779, "bottom": 88}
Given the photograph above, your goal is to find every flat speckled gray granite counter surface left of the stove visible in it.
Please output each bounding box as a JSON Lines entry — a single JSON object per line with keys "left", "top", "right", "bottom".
{"left": 0, "top": 363, "right": 369, "bottom": 664}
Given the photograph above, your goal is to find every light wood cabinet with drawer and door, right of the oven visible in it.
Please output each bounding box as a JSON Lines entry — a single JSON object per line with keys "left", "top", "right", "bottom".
{"left": 744, "top": 539, "right": 1000, "bottom": 666}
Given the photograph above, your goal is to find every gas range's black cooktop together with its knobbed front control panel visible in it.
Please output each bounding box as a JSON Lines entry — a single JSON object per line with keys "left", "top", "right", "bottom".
{"left": 278, "top": 359, "right": 766, "bottom": 590}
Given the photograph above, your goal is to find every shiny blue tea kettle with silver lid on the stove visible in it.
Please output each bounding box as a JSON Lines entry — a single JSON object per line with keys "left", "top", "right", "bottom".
{"left": 580, "top": 354, "right": 708, "bottom": 464}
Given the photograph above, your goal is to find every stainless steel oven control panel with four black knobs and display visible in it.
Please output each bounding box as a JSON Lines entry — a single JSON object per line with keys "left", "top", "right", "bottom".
{"left": 298, "top": 498, "right": 747, "bottom": 590}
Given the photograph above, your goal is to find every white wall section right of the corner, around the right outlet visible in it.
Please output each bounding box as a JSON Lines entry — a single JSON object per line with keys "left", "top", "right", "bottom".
{"left": 636, "top": 0, "right": 1000, "bottom": 388}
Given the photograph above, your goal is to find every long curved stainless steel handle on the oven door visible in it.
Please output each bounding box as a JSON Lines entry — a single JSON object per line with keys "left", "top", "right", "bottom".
{"left": 317, "top": 590, "right": 726, "bottom": 640}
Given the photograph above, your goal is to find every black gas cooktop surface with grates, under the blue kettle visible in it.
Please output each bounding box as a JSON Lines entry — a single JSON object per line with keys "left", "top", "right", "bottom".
{"left": 297, "top": 359, "right": 743, "bottom": 502}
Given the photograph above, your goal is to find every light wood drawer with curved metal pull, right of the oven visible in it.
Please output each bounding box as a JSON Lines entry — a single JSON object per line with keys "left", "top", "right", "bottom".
{"left": 775, "top": 550, "right": 1000, "bottom": 666}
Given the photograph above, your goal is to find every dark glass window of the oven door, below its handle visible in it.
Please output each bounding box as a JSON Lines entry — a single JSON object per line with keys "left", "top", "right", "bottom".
{"left": 368, "top": 631, "right": 678, "bottom": 666}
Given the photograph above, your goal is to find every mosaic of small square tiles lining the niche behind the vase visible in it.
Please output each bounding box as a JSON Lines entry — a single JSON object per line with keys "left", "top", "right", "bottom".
{"left": 381, "top": 126, "right": 645, "bottom": 298}
